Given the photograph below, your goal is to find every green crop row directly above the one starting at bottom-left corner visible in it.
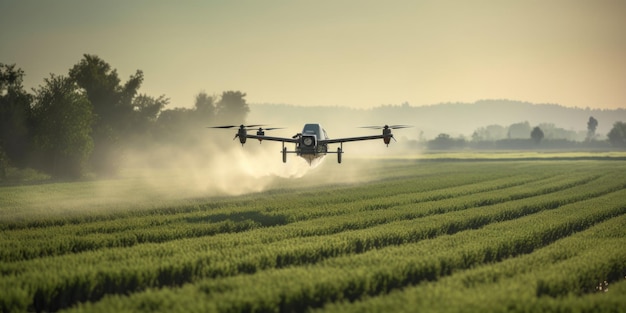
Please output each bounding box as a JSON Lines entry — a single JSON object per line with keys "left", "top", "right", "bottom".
{"left": 0, "top": 168, "right": 614, "bottom": 261}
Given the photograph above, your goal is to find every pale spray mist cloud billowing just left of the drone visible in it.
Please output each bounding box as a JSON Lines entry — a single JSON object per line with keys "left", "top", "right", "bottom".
{"left": 118, "top": 135, "right": 319, "bottom": 197}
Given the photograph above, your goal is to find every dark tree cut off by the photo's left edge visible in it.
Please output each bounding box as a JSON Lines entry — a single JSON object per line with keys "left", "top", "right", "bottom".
{"left": 0, "top": 63, "right": 32, "bottom": 166}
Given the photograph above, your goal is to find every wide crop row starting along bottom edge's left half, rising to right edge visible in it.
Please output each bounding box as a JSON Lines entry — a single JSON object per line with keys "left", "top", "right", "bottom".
{"left": 59, "top": 192, "right": 626, "bottom": 312}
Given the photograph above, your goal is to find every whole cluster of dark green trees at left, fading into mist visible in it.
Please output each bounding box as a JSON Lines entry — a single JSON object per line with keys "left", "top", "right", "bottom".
{"left": 0, "top": 54, "right": 250, "bottom": 179}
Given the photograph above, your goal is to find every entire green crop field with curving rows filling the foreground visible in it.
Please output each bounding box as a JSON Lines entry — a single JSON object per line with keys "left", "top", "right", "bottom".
{"left": 0, "top": 157, "right": 626, "bottom": 312}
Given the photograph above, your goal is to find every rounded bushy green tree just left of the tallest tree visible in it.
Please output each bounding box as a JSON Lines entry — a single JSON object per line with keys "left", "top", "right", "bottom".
{"left": 33, "top": 75, "right": 93, "bottom": 178}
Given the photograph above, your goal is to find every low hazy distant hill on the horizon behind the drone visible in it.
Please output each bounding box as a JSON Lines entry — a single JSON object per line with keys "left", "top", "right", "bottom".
{"left": 248, "top": 100, "right": 626, "bottom": 139}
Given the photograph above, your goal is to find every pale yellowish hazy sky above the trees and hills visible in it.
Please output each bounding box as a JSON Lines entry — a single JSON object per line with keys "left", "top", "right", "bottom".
{"left": 0, "top": 0, "right": 626, "bottom": 108}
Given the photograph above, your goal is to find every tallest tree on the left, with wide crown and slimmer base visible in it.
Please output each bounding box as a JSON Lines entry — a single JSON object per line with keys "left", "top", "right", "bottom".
{"left": 70, "top": 54, "right": 143, "bottom": 175}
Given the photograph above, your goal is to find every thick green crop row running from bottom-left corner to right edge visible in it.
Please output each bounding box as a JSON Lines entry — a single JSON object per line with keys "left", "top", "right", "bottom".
{"left": 0, "top": 183, "right": 626, "bottom": 309}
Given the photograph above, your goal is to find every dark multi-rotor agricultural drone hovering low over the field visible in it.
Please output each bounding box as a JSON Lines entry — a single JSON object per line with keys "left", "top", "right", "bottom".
{"left": 208, "top": 123, "right": 411, "bottom": 165}
